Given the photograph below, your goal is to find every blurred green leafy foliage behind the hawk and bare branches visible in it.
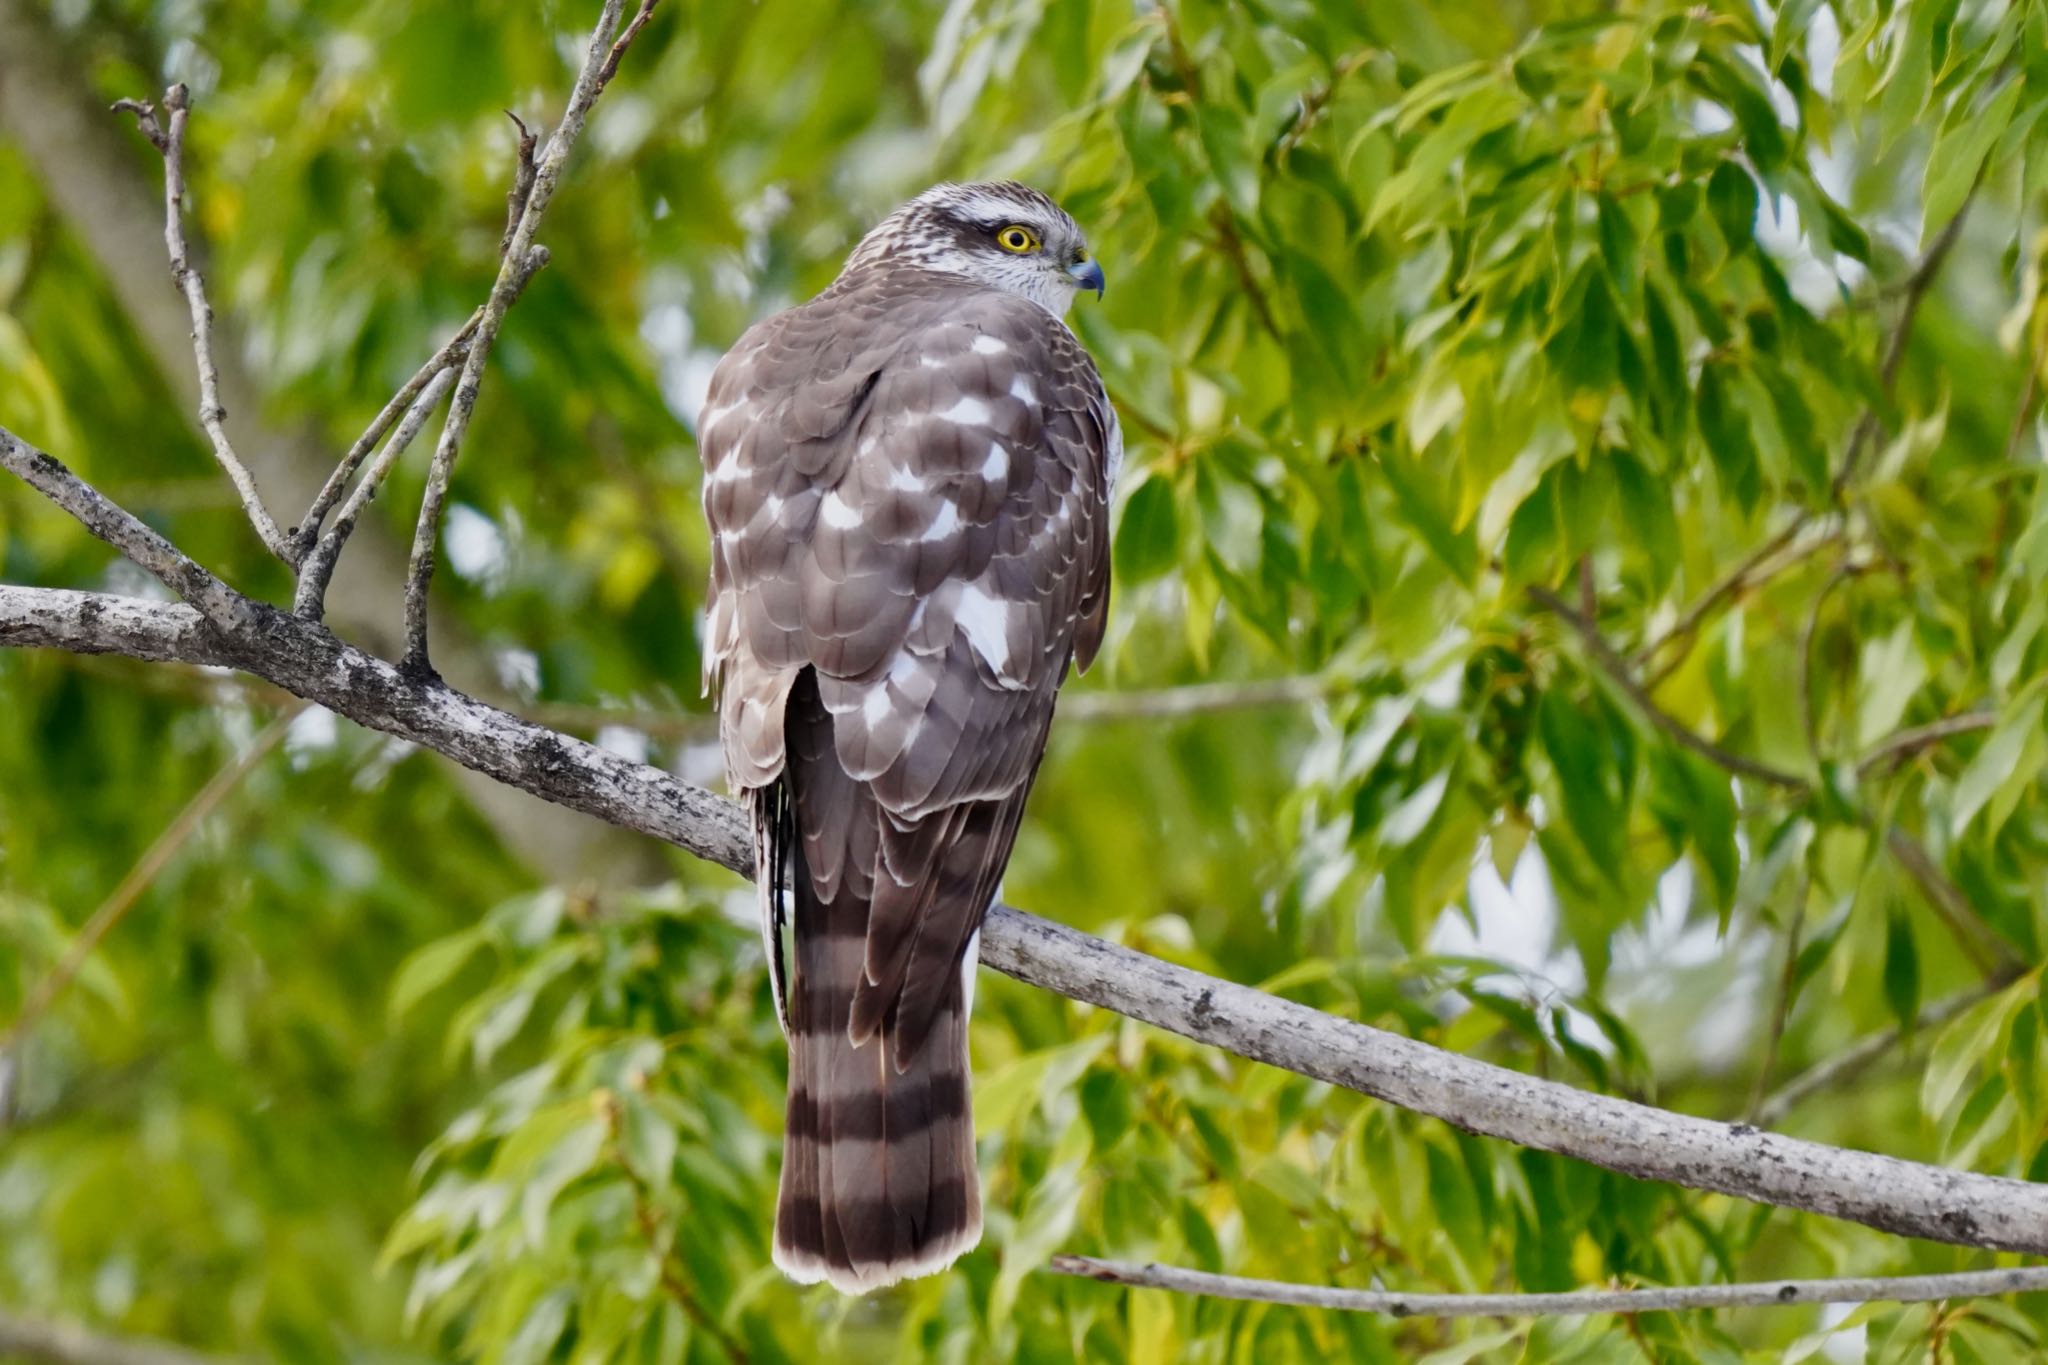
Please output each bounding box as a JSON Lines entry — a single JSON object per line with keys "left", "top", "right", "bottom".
{"left": 0, "top": 0, "right": 2048, "bottom": 1365}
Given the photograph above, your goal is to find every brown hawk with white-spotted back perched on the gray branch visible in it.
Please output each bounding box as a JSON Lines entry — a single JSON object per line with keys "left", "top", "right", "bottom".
{"left": 696, "top": 182, "right": 1122, "bottom": 1293}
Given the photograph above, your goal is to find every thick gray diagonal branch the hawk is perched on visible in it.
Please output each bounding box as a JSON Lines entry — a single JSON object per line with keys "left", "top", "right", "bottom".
{"left": 0, "top": 587, "right": 2048, "bottom": 1252}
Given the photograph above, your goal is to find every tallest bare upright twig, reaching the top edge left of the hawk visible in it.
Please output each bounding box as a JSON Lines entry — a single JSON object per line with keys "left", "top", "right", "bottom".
{"left": 403, "top": 0, "right": 653, "bottom": 675}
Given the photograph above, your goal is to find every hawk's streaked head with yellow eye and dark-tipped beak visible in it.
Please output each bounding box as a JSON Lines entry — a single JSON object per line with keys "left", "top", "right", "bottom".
{"left": 846, "top": 180, "right": 1104, "bottom": 317}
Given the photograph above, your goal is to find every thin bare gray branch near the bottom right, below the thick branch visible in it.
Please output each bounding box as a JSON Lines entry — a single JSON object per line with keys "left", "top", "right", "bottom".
{"left": 1047, "top": 1257, "right": 2048, "bottom": 1318}
